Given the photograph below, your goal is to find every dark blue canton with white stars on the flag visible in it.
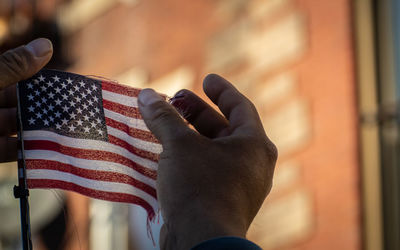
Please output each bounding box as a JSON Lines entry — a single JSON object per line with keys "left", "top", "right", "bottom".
{"left": 18, "top": 70, "right": 107, "bottom": 141}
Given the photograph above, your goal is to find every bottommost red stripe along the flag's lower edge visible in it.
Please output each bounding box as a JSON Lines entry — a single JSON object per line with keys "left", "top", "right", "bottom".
{"left": 27, "top": 179, "right": 155, "bottom": 220}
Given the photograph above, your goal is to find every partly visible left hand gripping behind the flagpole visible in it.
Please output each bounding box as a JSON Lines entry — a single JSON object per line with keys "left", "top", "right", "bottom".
{"left": 0, "top": 38, "right": 53, "bottom": 162}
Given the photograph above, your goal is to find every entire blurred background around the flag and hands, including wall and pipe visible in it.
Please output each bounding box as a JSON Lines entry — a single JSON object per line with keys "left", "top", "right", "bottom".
{"left": 0, "top": 0, "right": 400, "bottom": 250}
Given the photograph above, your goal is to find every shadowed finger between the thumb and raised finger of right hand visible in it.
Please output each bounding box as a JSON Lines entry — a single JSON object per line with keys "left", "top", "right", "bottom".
{"left": 171, "top": 89, "right": 229, "bottom": 138}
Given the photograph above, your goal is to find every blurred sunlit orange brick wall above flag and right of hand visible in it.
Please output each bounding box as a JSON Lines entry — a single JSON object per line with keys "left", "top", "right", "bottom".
{"left": 64, "top": 0, "right": 361, "bottom": 250}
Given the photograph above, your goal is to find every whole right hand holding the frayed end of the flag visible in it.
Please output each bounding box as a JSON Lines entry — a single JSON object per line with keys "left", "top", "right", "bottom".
{"left": 139, "top": 75, "right": 277, "bottom": 249}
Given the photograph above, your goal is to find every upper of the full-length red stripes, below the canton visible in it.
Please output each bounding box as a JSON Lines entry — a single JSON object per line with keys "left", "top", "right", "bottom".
{"left": 24, "top": 140, "right": 157, "bottom": 180}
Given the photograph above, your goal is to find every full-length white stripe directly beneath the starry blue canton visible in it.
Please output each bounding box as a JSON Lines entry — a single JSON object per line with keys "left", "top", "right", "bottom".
{"left": 23, "top": 130, "right": 157, "bottom": 170}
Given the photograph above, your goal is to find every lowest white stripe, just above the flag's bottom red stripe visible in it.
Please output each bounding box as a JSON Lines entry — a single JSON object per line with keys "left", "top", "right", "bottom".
{"left": 26, "top": 169, "right": 158, "bottom": 211}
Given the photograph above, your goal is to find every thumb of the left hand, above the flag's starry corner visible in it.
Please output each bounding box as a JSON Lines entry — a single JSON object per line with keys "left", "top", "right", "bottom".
{"left": 0, "top": 38, "right": 53, "bottom": 90}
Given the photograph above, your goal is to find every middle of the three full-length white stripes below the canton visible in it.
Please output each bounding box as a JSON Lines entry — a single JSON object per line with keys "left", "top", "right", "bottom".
{"left": 25, "top": 150, "right": 156, "bottom": 188}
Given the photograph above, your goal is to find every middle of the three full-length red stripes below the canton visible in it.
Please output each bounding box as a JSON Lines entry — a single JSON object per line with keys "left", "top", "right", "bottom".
{"left": 26, "top": 160, "right": 157, "bottom": 199}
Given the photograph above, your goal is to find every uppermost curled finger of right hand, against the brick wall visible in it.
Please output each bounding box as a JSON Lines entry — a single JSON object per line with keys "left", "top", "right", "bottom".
{"left": 203, "top": 74, "right": 262, "bottom": 134}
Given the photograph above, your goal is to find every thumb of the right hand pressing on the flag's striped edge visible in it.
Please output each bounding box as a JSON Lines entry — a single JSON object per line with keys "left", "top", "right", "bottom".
{"left": 138, "top": 89, "right": 190, "bottom": 145}
